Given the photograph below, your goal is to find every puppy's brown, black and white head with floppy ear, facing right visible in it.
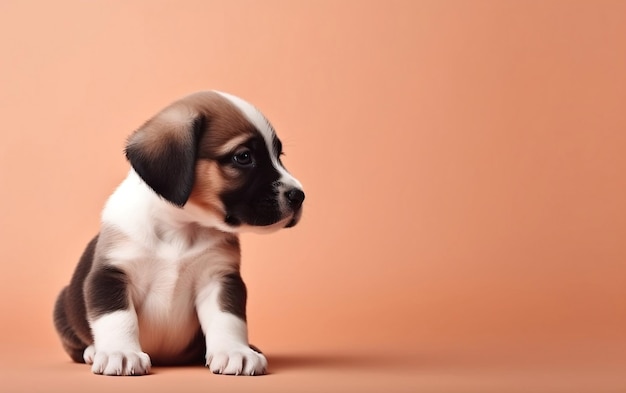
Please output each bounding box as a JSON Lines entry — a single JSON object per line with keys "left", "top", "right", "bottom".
{"left": 126, "top": 91, "right": 304, "bottom": 232}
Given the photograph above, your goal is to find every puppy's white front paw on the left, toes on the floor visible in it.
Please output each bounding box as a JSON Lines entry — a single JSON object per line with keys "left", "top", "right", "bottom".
{"left": 91, "top": 351, "right": 152, "bottom": 375}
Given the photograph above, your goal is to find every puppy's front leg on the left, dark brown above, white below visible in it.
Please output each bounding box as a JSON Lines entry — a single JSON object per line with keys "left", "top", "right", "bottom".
{"left": 85, "top": 265, "right": 151, "bottom": 375}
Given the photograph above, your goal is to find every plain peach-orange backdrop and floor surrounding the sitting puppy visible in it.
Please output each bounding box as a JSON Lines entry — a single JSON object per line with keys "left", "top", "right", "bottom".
{"left": 0, "top": 0, "right": 626, "bottom": 392}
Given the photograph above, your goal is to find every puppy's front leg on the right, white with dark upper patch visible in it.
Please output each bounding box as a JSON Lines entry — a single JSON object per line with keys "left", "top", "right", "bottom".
{"left": 196, "top": 273, "right": 267, "bottom": 375}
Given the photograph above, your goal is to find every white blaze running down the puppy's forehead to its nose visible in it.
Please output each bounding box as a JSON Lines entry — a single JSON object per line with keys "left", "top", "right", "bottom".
{"left": 215, "top": 91, "right": 302, "bottom": 189}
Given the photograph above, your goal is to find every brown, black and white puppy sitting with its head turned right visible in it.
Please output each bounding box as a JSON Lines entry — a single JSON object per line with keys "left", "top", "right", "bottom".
{"left": 54, "top": 91, "right": 304, "bottom": 375}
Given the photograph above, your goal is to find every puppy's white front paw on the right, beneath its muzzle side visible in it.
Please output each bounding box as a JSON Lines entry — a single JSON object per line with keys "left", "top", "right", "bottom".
{"left": 206, "top": 345, "right": 267, "bottom": 375}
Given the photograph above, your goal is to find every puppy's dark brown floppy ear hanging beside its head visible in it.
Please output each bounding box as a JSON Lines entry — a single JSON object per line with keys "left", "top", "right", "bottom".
{"left": 126, "top": 108, "right": 205, "bottom": 207}
